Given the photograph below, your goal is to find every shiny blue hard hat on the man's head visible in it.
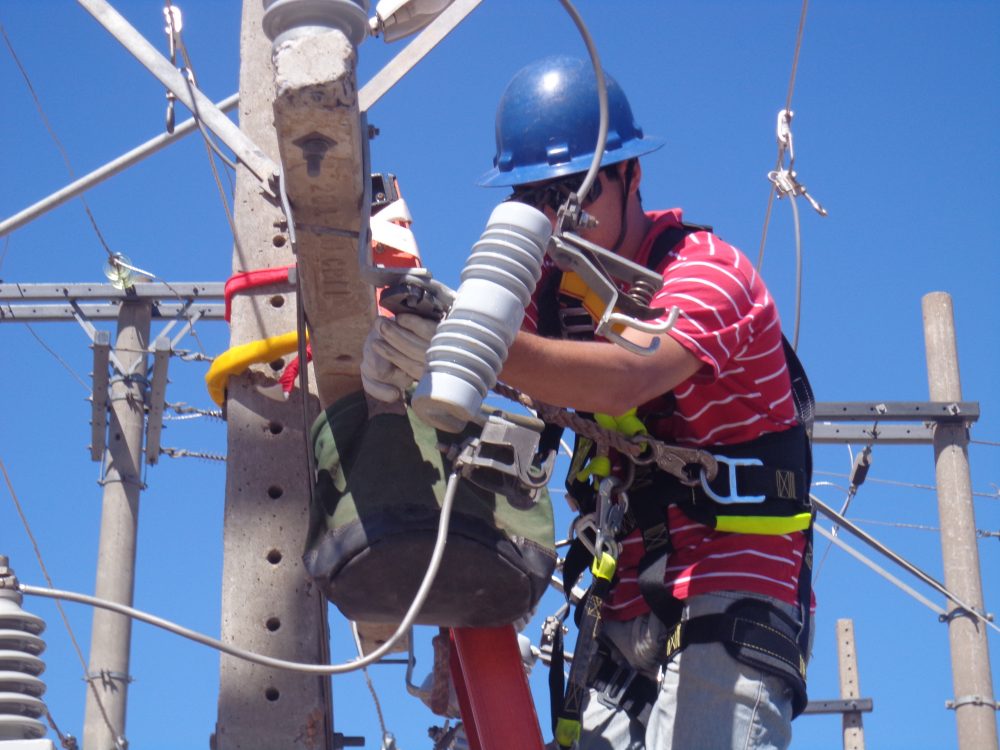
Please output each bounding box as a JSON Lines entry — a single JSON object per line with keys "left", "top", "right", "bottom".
{"left": 478, "top": 56, "right": 663, "bottom": 187}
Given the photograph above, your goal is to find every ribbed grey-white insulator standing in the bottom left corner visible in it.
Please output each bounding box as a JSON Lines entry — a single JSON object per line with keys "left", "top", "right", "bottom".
{"left": 0, "top": 591, "right": 47, "bottom": 747}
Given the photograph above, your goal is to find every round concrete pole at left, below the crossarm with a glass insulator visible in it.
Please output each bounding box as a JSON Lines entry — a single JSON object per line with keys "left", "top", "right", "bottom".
{"left": 83, "top": 300, "right": 151, "bottom": 750}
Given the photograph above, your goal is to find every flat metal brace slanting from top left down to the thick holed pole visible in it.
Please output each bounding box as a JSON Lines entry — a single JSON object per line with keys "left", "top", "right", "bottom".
{"left": 77, "top": 0, "right": 278, "bottom": 186}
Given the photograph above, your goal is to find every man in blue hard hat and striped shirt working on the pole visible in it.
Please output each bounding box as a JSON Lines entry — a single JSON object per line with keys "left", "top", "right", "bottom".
{"left": 366, "top": 57, "right": 811, "bottom": 750}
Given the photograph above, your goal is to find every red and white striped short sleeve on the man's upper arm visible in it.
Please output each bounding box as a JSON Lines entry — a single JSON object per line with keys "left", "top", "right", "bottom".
{"left": 651, "top": 232, "right": 777, "bottom": 380}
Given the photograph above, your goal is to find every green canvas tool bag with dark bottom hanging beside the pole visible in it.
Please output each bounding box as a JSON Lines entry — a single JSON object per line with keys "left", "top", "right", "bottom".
{"left": 303, "top": 392, "right": 556, "bottom": 627}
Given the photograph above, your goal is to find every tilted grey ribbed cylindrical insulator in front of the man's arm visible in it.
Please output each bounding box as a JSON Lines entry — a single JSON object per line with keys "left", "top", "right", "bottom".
{"left": 412, "top": 202, "right": 552, "bottom": 432}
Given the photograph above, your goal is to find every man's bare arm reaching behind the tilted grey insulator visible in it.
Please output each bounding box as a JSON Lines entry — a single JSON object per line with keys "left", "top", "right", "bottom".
{"left": 500, "top": 330, "right": 704, "bottom": 416}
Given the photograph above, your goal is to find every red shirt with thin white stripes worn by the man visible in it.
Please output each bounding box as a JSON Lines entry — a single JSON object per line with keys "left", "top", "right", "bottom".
{"left": 526, "top": 209, "right": 805, "bottom": 620}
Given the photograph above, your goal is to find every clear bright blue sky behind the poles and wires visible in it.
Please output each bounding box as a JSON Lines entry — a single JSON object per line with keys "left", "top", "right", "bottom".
{"left": 0, "top": 0, "right": 1000, "bottom": 750}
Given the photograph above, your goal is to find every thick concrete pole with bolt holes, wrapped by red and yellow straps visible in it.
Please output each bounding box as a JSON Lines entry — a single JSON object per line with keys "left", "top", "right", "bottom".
{"left": 214, "top": 0, "right": 333, "bottom": 750}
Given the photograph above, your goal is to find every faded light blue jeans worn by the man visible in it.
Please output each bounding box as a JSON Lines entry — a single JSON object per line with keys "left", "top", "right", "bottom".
{"left": 579, "top": 591, "right": 798, "bottom": 750}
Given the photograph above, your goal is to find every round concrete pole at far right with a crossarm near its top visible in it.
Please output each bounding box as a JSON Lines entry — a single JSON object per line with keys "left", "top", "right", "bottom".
{"left": 922, "top": 292, "right": 997, "bottom": 750}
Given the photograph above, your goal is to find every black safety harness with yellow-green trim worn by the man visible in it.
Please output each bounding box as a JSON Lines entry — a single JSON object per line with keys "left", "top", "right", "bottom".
{"left": 538, "top": 224, "right": 815, "bottom": 747}
